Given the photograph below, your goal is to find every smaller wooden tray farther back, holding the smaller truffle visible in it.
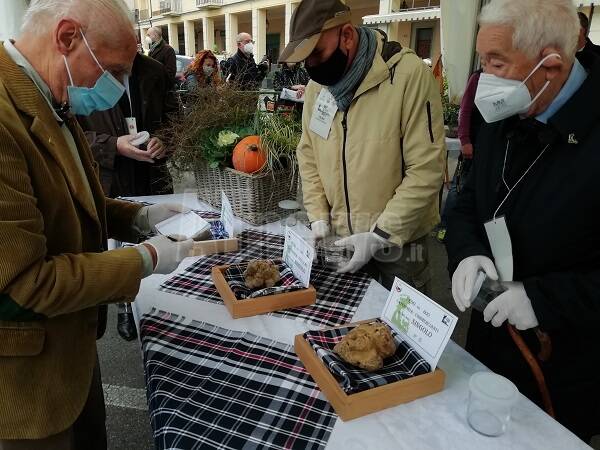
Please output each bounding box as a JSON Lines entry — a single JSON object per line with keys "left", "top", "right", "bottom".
{"left": 212, "top": 266, "right": 317, "bottom": 319}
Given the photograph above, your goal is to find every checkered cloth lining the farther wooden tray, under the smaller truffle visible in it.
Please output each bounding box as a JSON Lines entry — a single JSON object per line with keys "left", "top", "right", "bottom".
{"left": 224, "top": 261, "right": 304, "bottom": 300}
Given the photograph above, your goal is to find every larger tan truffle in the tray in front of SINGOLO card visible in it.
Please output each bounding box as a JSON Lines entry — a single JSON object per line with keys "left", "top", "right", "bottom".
{"left": 333, "top": 323, "right": 396, "bottom": 372}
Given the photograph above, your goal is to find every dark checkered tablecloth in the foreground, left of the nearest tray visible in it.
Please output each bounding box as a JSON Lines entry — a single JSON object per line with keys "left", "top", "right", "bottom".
{"left": 140, "top": 311, "right": 337, "bottom": 450}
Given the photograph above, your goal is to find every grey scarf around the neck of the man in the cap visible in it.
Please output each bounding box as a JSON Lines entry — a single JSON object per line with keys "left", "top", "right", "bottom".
{"left": 329, "top": 28, "right": 377, "bottom": 111}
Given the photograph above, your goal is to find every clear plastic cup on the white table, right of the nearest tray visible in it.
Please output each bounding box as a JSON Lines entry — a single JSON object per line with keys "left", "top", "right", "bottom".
{"left": 467, "top": 372, "right": 519, "bottom": 437}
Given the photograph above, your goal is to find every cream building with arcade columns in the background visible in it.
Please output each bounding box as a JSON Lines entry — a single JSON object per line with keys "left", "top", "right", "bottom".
{"left": 133, "top": 0, "right": 441, "bottom": 62}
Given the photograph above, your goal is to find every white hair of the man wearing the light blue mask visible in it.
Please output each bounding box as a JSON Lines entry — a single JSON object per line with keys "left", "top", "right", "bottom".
{"left": 21, "top": 0, "right": 134, "bottom": 43}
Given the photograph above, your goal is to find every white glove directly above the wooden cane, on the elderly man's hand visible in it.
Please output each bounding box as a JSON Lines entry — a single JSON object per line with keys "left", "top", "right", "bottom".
{"left": 483, "top": 282, "right": 539, "bottom": 330}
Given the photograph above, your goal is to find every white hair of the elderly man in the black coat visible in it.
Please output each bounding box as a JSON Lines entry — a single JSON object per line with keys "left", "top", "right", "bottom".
{"left": 479, "top": 0, "right": 581, "bottom": 59}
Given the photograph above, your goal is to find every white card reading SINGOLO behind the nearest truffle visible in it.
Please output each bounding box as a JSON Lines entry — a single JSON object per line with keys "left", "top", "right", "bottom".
{"left": 381, "top": 278, "right": 458, "bottom": 371}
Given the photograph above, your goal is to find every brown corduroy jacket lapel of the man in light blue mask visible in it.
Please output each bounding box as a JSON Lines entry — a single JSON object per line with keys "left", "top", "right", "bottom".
{"left": 0, "top": 42, "right": 101, "bottom": 227}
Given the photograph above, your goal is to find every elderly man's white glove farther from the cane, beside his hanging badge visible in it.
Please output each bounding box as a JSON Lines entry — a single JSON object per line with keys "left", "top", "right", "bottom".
{"left": 452, "top": 256, "right": 498, "bottom": 312}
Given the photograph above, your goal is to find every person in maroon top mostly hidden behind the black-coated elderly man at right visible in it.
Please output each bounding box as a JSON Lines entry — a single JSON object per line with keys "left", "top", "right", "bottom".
{"left": 437, "top": 69, "right": 483, "bottom": 242}
